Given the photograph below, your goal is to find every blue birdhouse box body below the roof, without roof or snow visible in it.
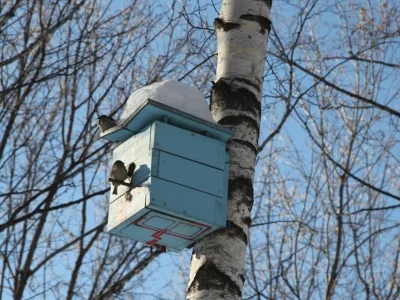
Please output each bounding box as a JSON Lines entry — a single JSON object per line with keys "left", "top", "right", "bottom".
{"left": 108, "top": 121, "right": 229, "bottom": 251}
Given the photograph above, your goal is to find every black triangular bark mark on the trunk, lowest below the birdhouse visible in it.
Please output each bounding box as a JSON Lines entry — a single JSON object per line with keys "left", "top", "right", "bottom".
{"left": 188, "top": 262, "right": 242, "bottom": 298}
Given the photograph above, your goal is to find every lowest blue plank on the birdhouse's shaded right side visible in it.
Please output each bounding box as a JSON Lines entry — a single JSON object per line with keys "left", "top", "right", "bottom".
{"left": 146, "top": 177, "right": 222, "bottom": 226}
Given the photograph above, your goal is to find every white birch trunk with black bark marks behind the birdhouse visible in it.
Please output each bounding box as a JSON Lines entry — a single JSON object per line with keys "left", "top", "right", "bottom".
{"left": 187, "top": 0, "right": 272, "bottom": 300}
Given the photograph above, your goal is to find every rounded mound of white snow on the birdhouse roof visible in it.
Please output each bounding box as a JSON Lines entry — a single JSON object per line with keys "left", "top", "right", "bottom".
{"left": 121, "top": 80, "right": 215, "bottom": 123}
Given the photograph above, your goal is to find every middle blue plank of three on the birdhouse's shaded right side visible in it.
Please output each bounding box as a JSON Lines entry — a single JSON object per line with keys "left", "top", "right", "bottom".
{"left": 159, "top": 151, "right": 224, "bottom": 197}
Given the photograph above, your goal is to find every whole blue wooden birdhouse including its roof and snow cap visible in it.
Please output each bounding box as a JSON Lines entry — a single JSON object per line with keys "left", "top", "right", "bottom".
{"left": 101, "top": 81, "right": 232, "bottom": 251}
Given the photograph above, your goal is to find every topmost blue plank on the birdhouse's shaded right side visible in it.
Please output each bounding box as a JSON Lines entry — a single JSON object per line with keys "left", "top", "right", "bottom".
{"left": 151, "top": 121, "right": 225, "bottom": 170}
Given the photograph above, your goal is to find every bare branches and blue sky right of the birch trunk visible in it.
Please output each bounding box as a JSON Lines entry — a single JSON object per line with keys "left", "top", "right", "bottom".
{"left": 247, "top": 0, "right": 400, "bottom": 299}
